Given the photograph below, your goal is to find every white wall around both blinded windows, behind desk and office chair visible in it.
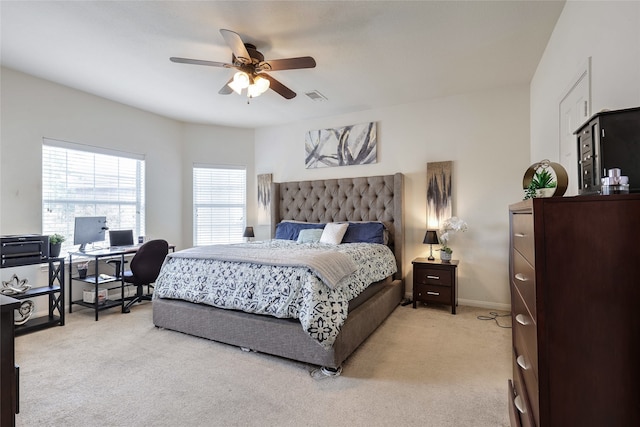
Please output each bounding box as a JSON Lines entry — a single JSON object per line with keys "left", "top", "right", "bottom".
{"left": 0, "top": 68, "right": 256, "bottom": 308}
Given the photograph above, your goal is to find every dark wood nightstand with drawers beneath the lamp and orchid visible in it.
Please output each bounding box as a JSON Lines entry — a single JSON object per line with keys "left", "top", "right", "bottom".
{"left": 411, "top": 258, "right": 458, "bottom": 314}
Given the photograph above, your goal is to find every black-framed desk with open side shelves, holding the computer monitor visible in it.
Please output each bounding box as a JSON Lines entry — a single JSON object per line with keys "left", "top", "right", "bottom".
{"left": 69, "top": 244, "right": 176, "bottom": 321}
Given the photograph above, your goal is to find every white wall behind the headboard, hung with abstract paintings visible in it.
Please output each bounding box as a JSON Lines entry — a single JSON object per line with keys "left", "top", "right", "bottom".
{"left": 255, "top": 86, "right": 529, "bottom": 308}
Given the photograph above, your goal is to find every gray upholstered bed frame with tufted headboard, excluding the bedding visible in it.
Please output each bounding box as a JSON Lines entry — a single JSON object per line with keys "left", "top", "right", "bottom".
{"left": 153, "top": 173, "right": 404, "bottom": 369}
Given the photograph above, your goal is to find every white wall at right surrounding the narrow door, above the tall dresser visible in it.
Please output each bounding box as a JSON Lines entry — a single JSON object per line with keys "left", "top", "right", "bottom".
{"left": 530, "top": 1, "right": 640, "bottom": 164}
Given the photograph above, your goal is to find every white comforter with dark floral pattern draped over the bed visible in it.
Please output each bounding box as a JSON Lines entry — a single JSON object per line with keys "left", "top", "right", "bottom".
{"left": 154, "top": 240, "right": 397, "bottom": 348}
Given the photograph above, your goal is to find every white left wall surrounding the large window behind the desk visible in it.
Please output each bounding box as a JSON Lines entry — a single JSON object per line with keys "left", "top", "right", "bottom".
{"left": 0, "top": 68, "right": 182, "bottom": 246}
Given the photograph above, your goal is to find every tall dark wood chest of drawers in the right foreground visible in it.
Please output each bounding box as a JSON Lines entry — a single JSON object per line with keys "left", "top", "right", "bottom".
{"left": 509, "top": 194, "right": 640, "bottom": 427}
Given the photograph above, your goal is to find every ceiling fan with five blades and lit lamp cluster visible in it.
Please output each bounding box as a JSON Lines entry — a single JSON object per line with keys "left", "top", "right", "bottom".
{"left": 169, "top": 29, "right": 316, "bottom": 99}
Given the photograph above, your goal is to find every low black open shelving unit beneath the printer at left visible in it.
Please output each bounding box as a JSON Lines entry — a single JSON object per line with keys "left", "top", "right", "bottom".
{"left": 4, "top": 258, "right": 64, "bottom": 336}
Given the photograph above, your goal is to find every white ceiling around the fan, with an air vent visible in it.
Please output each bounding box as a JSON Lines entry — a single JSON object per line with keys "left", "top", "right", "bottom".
{"left": 0, "top": 0, "right": 564, "bottom": 128}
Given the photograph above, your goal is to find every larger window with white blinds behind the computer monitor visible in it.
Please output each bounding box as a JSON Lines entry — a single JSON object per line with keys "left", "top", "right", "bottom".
{"left": 42, "top": 138, "right": 145, "bottom": 256}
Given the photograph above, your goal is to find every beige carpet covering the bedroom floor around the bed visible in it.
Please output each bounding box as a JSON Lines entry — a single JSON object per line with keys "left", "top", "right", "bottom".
{"left": 16, "top": 303, "right": 511, "bottom": 427}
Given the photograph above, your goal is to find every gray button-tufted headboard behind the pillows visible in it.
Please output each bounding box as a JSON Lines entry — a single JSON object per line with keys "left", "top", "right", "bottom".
{"left": 271, "top": 173, "right": 404, "bottom": 279}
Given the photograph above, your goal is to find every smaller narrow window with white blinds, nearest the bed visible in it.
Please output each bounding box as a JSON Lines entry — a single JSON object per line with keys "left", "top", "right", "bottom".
{"left": 193, "top": 165, "right": 247, "bottom": 246}
